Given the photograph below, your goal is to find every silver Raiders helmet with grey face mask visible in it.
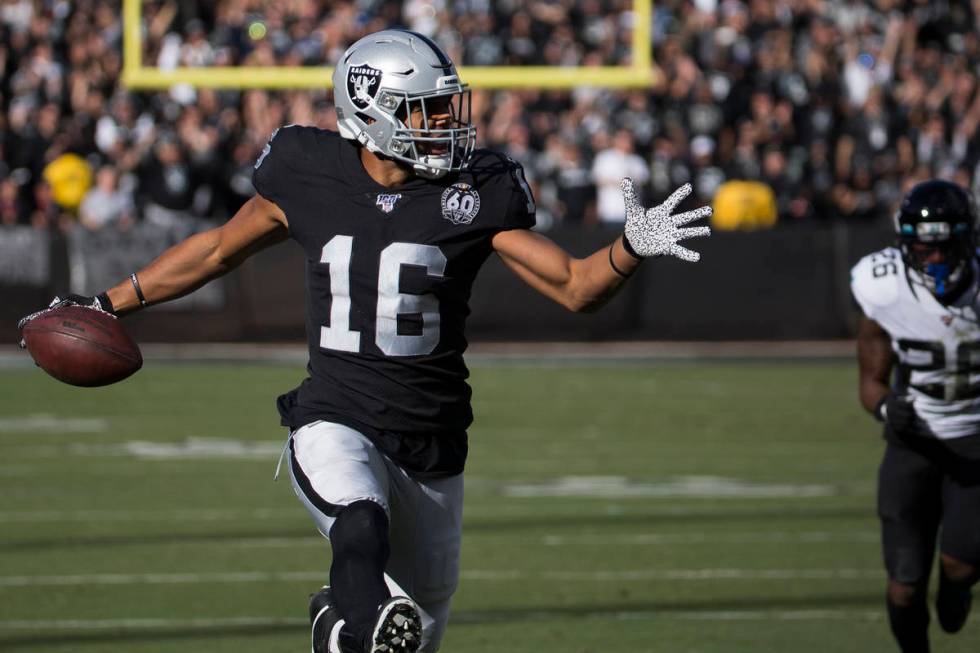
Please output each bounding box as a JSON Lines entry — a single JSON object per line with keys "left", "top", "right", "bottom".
{"left": 333, "top": 29, "right": 476, "bottom": 179}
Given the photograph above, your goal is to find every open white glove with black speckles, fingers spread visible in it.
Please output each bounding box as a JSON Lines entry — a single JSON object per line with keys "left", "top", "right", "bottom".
{"left": 620, "top": 177, "right": 711, "bottom": 263}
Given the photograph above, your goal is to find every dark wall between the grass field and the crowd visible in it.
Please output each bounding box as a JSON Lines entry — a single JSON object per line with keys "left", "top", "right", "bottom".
{"left": 0, "top": 222, "right": 892, "bottom": 342}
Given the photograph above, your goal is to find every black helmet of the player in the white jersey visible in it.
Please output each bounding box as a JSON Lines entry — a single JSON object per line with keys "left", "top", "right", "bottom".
{"left": 895, "top": 180, "right": 978, "bottom": 300}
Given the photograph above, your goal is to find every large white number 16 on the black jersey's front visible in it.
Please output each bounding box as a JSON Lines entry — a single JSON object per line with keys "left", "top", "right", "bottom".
{"left": 320, "top": 236, "right": 447, "bottom": 356}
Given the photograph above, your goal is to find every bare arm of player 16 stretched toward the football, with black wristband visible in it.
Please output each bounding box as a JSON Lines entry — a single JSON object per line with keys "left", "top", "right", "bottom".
{"left": 106, "top": 194, "right": 289, "bottom": 315}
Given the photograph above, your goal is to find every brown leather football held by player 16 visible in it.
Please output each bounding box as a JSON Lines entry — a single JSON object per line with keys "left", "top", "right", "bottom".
{"left": 22, "top": 306, "right": 143, "bottom": 387}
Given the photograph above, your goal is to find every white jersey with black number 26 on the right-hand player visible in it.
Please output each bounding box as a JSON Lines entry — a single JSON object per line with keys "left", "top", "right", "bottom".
{"left": 851, "top": 247, "right": 980, "bottom": 440}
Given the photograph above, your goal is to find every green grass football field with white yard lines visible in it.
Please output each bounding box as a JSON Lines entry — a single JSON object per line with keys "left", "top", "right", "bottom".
{"left": 0, "top": 360, "right": 980, "bottom": 653}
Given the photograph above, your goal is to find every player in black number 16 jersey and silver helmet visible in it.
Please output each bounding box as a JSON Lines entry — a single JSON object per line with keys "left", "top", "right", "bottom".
{"left": 19, "top": 30, "right": 711, "bottom": 653}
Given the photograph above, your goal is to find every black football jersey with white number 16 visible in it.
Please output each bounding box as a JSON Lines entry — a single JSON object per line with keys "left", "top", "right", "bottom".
{"left": 252, "top": 126, "right": 534, "bottom": 477}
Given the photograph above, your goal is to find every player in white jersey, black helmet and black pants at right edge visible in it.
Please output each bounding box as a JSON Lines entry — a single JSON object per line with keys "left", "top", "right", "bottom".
{"left": 851, "top": 180, "right": 980, "bottom": 653}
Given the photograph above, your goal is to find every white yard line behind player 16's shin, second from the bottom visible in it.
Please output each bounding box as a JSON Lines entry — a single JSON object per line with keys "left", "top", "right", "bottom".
{"left": 0, "top": 569, "right": 884, "bottom": 587}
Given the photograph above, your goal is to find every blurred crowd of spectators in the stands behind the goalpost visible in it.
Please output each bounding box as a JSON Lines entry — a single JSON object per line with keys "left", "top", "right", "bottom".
{"left": 0, "top": 0, "right": 980, "bottom": 230}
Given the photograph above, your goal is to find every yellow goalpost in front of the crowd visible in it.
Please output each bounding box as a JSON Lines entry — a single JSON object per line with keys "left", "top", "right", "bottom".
{"left": 122, "top": 0, "right": 656, "bottom": 90}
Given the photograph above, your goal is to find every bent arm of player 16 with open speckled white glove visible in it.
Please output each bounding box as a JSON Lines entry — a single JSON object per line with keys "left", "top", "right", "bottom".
{"left": 493, "top": 179, "right": 711, "bottom": 312}
